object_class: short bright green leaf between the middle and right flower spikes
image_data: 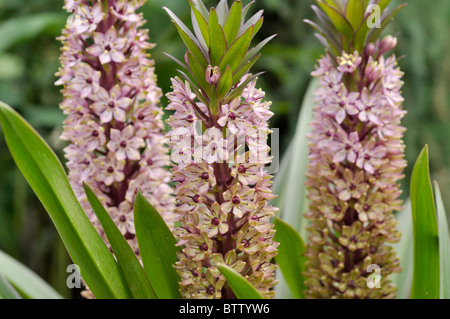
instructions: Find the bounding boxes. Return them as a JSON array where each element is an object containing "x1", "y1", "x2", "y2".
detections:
[{"x1": 274, "y1": 218, "x2": 306, "y2": 299}]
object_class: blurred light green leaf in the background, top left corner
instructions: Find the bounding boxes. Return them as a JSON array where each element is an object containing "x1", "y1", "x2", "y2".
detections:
[{"x1": 0, "y1": 13, "x2": 67, "y2": 52}]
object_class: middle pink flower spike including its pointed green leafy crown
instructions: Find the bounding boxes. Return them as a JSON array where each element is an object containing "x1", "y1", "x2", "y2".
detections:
[{"x1": 166, "y1": 0, "x2": 278, "y2": 299}]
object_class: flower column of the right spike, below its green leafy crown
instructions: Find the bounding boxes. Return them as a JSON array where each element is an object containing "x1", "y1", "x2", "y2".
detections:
[{"x1": 305, "y1": 1, "x2": 406, "y2": 298}]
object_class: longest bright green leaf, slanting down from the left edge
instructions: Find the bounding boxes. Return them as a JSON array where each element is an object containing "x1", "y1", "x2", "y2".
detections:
[{"x1": 0, "y1": 102, "x2": 129, "y2": 298}]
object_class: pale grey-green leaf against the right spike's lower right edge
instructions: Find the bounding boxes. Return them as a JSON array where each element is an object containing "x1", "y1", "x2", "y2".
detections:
[{"x1": 390, "y1": 199, "x2": 414, "y2": 299}]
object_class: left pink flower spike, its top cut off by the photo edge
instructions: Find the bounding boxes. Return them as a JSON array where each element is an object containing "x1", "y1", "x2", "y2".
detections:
[{"x1": 56, "y1": 0, "x2": 175, "y2": 264}]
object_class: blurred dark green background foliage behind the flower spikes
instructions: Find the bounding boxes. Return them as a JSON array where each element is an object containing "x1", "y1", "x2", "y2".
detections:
[{"x1": 0, "y1": 0, "x2": 450, "y2": 297}]
